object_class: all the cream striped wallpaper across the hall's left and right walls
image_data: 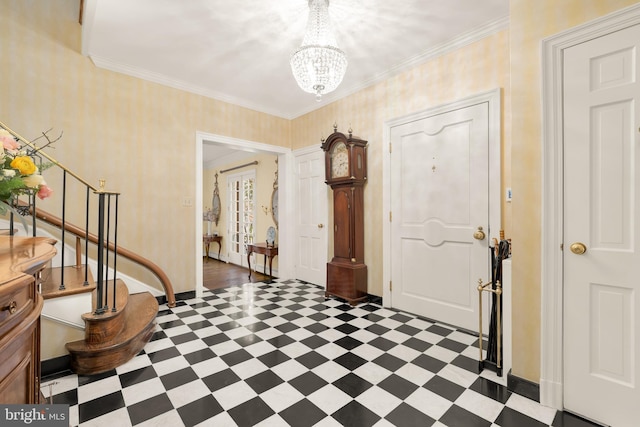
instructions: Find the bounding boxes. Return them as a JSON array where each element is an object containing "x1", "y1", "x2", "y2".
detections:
[{"x1": 0, "y1": 0, "x2": 636, "y2": 383}]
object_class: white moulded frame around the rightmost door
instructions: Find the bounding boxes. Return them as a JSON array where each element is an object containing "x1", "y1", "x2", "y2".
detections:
[{"x1": 540, "y1": 4, "x2": 640, "y2": 409}]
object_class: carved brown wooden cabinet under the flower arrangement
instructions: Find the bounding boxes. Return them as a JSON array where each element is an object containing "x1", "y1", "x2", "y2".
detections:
[{"x1": 0, "y1": 236, "x2": 55, "y2": 404}]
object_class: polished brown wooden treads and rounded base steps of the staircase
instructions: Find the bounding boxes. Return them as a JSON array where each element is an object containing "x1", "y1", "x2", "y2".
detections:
[{"x1": 41, "y1": 266, "x2": 158, "y2": 375}]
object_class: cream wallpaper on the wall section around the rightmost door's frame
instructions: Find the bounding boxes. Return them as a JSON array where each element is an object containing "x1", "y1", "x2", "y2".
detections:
[{"x1": 510, "y1": 0, "x2": 636, "y2": 383}]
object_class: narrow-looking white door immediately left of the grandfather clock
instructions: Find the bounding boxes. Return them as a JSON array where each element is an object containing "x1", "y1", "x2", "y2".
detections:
[{"x1": 295, "y1": 148, "x2": 328, "y2": 287}]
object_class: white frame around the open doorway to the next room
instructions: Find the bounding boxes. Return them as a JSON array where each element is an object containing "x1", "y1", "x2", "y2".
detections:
[{"x1": 193, "y1": 131, "x2": 295, "y2": 298}]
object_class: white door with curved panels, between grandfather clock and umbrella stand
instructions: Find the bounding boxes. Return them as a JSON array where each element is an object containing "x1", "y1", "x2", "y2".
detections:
[{"x1": 390, "y1": 102, "x2": 490, "y2": 331}]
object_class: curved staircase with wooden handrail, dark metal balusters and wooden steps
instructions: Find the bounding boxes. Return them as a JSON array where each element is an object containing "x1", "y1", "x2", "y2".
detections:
[{"x1": 0, "y1": 121, "x2": 176, "y2": 374}]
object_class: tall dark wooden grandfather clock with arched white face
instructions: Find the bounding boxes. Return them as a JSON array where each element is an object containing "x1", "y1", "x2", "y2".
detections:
[{"x1": 322, "y1": 125, "x2": 367, "y2": 305}]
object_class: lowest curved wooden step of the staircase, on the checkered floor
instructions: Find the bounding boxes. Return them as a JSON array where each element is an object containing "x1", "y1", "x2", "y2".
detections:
[{"x1": 66, "y1": 292, "x2": 158, "y2": 375}]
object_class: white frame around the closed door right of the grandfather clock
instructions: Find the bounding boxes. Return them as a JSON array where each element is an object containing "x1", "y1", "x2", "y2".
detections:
[{"x1": 382, "y1": 88, "x2": 502, "y2": 307}]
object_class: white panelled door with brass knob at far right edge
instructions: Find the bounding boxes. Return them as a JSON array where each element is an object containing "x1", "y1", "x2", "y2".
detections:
[{"x1": 563, "y1": 25, "x2": 640, "y2": 427}]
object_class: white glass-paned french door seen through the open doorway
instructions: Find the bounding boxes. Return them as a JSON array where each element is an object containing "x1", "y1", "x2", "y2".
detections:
[{"x1": 227, "y1": 170, "x2": 256, "y2": 267}]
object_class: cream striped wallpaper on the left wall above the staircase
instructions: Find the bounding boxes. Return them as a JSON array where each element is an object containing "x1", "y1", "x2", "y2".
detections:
[{"x1": 0, "y1": 0, "x2": 291, "y2": 292}]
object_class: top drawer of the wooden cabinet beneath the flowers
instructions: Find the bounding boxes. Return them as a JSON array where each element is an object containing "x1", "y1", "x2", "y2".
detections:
[{"x1": 0, "y1": 276, "x2": 35, "y2": 337}]
